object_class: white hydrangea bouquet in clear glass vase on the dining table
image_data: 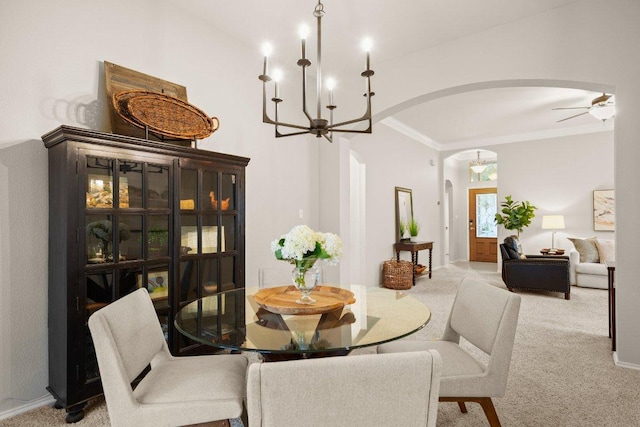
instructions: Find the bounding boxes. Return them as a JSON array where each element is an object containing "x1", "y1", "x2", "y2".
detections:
[{"x1": 271, "y1": 225, "x2": 342, "y2": 304}]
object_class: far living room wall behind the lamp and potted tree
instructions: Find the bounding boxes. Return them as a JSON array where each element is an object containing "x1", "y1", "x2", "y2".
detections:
[{"x1": 443, "y1": 131, "x2": 615, "y2": 261}]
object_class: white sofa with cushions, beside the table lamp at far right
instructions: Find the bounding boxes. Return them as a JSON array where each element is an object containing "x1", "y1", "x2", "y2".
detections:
[{"x1": 569, "y1": 238, "x2": 615, "y2": 289}]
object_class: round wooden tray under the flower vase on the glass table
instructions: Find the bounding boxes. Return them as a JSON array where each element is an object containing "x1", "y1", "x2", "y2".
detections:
[{"x1": 253, "y1": 286, "x2": 356, "y2": 314}]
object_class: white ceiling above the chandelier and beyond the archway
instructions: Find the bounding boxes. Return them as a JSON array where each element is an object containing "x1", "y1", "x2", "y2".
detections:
[{"x1": 174, "y1": 0, "x2": 613, "y2": 150}]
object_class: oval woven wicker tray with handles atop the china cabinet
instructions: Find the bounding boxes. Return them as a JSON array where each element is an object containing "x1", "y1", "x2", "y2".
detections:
[{"x1": 113, "y1": 90, "x2": 220, "y2": 139}]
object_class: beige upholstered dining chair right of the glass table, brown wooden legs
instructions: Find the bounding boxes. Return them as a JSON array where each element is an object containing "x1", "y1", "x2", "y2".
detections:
[{"x1": 378, "y1": 279, "x2": 520, "y2": 427}]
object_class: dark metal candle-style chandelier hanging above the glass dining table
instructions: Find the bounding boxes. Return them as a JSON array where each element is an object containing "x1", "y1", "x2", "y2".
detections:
[{"x1": 258, "y1": 0, "x2": 375, "y2": 142}]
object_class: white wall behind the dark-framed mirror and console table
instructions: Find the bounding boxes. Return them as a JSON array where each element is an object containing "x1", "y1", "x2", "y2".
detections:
[{"x1": 351, "y1": 124, "x2": 441, "y2": 286}]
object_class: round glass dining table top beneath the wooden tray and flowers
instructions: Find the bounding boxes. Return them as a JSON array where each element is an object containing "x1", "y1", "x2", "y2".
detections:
[{"x1": 175, "y1": 285, "x2": 431, "y2": 361}]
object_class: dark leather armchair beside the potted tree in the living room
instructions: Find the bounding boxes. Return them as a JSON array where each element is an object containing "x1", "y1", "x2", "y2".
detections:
[{"x1": 500, "y1": 237, "x2": 571, "y2": 300}]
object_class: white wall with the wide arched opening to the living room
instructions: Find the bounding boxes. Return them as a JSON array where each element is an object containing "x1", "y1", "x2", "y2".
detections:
[{"x1": 364, "y1": 0, "x2": 640, "y2": 369}]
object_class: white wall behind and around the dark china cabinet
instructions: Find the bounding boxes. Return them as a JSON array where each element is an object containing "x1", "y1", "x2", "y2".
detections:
[{"x1": 0, "y1": 0, "x2": 319, "y2": 414}]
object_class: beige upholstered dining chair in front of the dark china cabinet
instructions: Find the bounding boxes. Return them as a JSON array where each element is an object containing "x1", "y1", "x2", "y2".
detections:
[{"x1": 89, "y1": 289, "x2": 247, "y2": 427}]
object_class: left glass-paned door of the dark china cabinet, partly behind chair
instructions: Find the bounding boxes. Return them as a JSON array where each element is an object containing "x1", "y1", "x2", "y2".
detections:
[{"x1": 79, "y1": 153, "x2": 172, "y2": 381}]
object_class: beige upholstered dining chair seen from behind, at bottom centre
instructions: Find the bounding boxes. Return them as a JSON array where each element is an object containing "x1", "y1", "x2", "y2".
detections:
[{"x1": 247, "y1": 351, "x2": 442, "y2": 427}]
